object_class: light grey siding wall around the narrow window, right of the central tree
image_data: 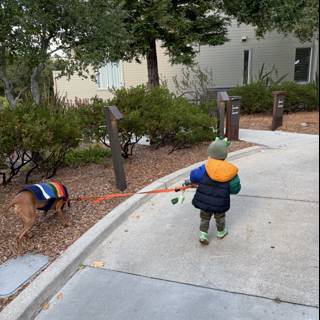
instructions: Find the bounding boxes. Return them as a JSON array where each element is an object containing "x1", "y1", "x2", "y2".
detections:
[{"x1": 197, "y1": 22, "x2": 313, "y2": 87}]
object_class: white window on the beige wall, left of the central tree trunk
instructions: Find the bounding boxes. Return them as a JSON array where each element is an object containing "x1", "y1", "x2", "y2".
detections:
[{"x1": 97, "y1": 63, "x2": 123, "y2": 90}]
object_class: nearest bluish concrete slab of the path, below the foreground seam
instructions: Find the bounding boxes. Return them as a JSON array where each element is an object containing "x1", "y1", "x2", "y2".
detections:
[{"x1": 37, "y1": 268, "x2": 317, "y2": 320}]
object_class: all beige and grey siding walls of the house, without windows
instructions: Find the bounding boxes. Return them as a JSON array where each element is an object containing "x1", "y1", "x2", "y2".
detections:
[{"x1": 54, "y1": 22, "x2": 318, "y2": 100}]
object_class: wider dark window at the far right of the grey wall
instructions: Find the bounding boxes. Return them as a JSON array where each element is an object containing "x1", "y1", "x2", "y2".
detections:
[{"x1": 294, "y1": 48, "x2": 311, "y2": 82}]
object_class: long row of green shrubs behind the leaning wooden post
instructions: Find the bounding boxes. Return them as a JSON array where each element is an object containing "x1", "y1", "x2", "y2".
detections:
[{"x1": 0, "y1": 86, "x2": 217, "y2": 184}]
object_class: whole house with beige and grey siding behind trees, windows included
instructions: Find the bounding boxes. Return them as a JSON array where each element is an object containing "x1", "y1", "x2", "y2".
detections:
[{"x1": 53, "y1": 21, "x2": 319, "y2": 100}]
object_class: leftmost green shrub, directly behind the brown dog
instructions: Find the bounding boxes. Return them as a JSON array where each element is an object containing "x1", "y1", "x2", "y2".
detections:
[{"x1": 0, "y1": 103, "x2": 81, "y2": 183}]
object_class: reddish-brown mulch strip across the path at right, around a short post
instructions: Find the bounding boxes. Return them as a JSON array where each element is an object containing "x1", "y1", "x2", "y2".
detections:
[{"x1": 240, "y1": 111, "x2": 319, "y2": 134}]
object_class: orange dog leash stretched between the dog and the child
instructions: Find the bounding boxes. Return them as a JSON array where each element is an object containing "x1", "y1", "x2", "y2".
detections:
[{"x1": 70, "y1": 185, "x2": 194, "y2": 204}]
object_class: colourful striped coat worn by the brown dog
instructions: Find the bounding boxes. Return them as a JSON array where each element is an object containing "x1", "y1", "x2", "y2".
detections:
[{"x1": 20, "y1": 181, "x2": 69, "y2": 211}]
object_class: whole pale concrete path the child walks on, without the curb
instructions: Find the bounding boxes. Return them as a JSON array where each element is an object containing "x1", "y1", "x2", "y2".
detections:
[{"x1": 33, "y1": 131, "x2": 319, "y2": 320}]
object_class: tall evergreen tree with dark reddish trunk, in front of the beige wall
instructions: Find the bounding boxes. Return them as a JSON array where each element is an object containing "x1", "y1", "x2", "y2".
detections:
[{"x1": 119, "y1": 0, "x2": 229, "y2": 86}]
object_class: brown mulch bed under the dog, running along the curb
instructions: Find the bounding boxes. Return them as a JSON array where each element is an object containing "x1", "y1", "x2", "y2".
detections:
[{"x1": 0, "y1": 141, "x2": 253, "y2": 311}]
